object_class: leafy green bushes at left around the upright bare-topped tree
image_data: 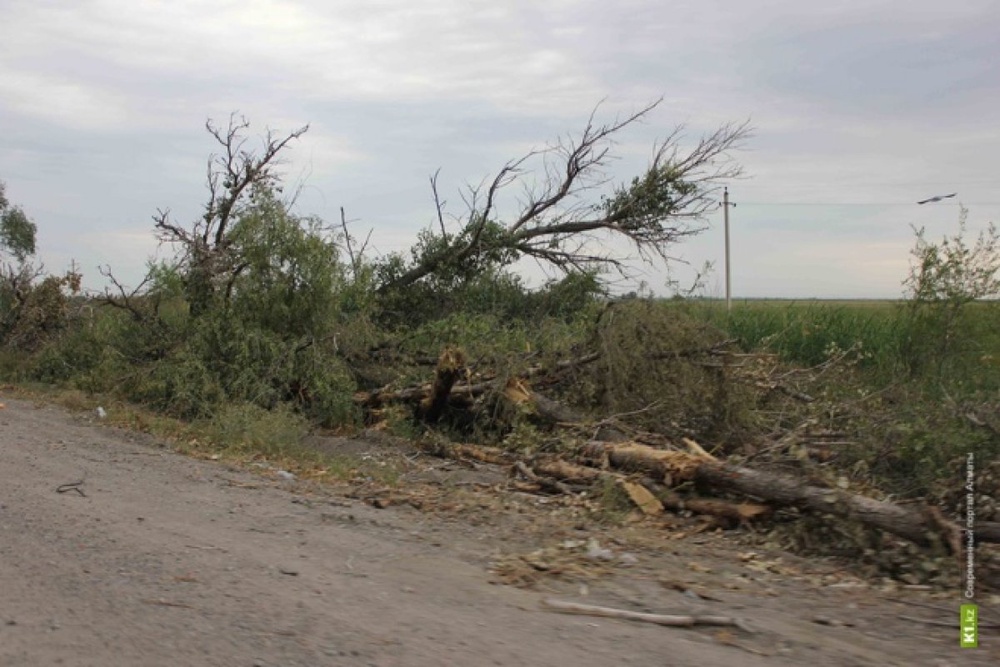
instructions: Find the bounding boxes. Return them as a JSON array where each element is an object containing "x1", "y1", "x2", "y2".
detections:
[{"x1": 8, "y1": 180, "x2": 369, "y2": 425}]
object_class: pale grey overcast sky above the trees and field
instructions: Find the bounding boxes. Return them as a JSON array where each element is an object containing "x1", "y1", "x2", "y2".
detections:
[{"x1": 0, "y1": 0, "x2": 1000, "y2": 298}]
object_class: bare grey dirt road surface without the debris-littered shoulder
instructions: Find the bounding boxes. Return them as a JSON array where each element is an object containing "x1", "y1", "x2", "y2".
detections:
[{"x1": 0, "y1": 400, "x2": 1000, "y2": 667}]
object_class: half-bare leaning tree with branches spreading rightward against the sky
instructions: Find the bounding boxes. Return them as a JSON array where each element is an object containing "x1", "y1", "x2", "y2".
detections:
[{"x1": 379, "y1": 102, "x2": 749, "y2": 293}]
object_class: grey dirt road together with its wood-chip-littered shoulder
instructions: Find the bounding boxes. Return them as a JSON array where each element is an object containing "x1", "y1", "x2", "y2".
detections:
[{"x1": 0, "y1": 400, "x2": 1000, "y2": 667}]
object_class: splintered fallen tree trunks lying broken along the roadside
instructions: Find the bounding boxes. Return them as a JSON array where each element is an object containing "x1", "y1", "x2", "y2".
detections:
[{"x1": 356, "y1": 341, "x2": 1000, "y2": 553}]
